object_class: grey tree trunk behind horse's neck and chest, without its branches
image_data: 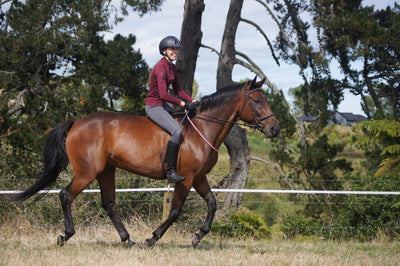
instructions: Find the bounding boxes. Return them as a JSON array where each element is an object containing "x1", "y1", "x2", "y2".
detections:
[{"x1": 217, "y1": 0, "x2": 250, "y2": 208}]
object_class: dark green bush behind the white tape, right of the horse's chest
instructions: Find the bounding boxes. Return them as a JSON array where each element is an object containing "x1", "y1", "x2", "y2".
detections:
[{"x1": 271, "y1": 134, "x2": 352, "y2": 217}]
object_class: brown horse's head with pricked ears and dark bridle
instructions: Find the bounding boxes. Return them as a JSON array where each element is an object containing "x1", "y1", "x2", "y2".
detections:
[{"x1": 240, "y1": 77, "x2": 280, "y2": 138}]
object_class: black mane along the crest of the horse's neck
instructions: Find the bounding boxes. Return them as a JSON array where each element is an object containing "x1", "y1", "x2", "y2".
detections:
[{"x1": 199, "y1": 82, "x2": 246, "y2": 112}]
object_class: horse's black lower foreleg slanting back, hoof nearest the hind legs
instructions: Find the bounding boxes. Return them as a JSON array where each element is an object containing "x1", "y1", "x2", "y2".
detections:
[{"x1": 144, "y1": 183, "x2": 190, "y2": 247}]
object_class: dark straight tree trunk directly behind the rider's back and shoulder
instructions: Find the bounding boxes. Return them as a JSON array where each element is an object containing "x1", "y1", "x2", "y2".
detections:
[{"x1": 176, "y1": 0, "x2": 205, "y2": 95}]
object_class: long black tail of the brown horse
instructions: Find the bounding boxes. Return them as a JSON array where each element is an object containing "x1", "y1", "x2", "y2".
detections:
[{"x1": 13, "y1": 120, "x2": 74, "y2": 201}]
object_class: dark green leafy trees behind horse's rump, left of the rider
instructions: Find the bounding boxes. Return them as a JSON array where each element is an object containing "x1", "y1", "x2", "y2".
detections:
[{"x1": 0, "y1": 0, "x2": 162, "y2": 176}]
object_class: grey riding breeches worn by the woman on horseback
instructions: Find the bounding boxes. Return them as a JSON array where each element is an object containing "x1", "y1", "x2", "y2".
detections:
[{"x1": 145, "y1": 104, "x2": 183, "y2": 145}]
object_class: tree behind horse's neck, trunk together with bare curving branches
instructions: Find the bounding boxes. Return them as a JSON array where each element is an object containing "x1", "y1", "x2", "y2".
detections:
[{"x1": 202, "y1": 0, "x2": 296, "y2": 207}]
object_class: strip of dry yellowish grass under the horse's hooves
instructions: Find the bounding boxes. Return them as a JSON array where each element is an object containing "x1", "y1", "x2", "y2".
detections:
[{"x1": 0, "y1": 217, "x2": 400, "y2": 265}]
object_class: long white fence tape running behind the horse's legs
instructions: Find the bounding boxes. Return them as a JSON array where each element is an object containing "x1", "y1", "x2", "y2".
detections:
[{"x1": 0, "y1": 187, "x2": 400, "y2": 195}]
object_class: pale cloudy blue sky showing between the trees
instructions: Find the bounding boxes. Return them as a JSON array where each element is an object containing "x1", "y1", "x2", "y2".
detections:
[{"x1": 105, "y1": 0, "x2": 396, "y2": 114}]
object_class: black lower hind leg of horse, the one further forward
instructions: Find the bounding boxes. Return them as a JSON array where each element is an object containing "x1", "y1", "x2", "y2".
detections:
[{"x1": 97, "y1": 166, "x2": 136, "y2": 247}]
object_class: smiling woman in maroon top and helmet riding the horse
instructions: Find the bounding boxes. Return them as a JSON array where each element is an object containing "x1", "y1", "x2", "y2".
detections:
[{"x1": 145, "y1": 36, "x2": 196, "y2": 183}]
